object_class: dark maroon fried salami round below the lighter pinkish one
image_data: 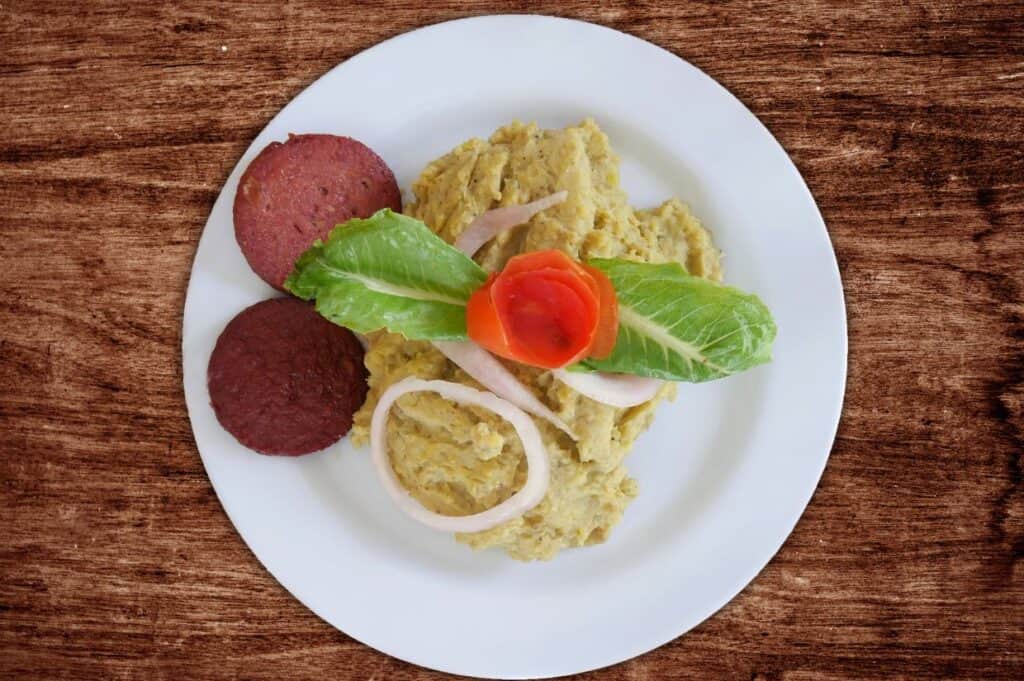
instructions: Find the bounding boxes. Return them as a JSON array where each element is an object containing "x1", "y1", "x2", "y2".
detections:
[{"x1": 207, "y1": 298, "x2": 367, "y2": 456}]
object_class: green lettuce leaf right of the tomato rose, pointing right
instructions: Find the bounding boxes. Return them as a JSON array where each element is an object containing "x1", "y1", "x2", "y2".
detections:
[{"x1": 583, "y1": 259, "x2": 775, "y2": 383}]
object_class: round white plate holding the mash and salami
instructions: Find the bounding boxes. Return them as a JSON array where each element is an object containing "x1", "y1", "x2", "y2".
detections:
[{"x1": 182, "y1": 15, "x2": 846, "y2": 678}]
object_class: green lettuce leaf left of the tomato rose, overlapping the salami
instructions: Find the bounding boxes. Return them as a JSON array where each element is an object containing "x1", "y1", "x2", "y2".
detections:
[{"x1": 285, "y1": 208, "x2": 486, "y2": 340}]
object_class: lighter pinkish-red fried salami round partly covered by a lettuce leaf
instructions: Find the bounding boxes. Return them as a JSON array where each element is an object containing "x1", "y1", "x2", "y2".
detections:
[{"x1": 233, "y1": 135, "x2": 401, "y2": 290}]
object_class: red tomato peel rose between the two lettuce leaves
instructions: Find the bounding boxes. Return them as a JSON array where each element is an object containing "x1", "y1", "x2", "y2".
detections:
[{"x1": 466, "y1": 250, "x2": 618, "y2": 369}]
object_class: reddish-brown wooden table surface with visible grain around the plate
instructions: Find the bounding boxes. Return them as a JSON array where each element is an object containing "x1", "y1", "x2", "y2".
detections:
[{"x1": 0, "y1": 0, "x2": 1024, "y2": 680}]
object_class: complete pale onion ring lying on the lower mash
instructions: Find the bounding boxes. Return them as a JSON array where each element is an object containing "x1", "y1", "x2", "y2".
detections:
[{"x1": 370, "y1": 378, "x2": 551, "y2": 533}]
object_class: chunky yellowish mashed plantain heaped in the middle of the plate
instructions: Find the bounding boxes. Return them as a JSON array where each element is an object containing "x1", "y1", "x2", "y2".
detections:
[{"x1": 353, "y1": 120, "x2": 721, "y2": 560}]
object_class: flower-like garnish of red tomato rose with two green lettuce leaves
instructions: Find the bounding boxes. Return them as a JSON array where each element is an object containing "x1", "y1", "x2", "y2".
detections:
[{"x1": 285, "y1": 210, "x2": 775, "y2": 382}]
